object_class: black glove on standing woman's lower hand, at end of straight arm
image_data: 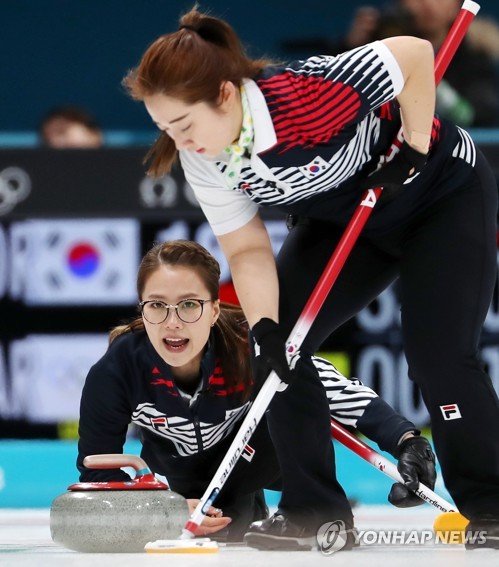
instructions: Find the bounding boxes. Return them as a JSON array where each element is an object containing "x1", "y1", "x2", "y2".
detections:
[{"x1": 252, "y1": 318, "x2": 292, "y2": 389}]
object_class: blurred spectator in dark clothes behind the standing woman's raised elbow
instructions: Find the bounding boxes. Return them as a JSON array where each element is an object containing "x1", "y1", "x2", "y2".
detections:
[{"x1": 283, "y1": 0, "x2": 499, "y2": 127}]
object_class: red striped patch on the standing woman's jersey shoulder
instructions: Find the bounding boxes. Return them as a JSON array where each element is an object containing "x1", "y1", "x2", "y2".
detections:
[{"x1": 257, "y1": 72, "x2": 360, "y2": 152}]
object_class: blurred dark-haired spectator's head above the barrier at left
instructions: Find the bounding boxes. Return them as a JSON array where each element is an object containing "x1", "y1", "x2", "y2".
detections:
[{"x1": 39, "y1": 106, "x2": 103, "y2": 149}]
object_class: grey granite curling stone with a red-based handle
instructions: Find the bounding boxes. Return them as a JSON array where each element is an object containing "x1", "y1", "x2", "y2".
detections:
[{"x1": 50, "y1": 454, "x2": 189, "y2": 553}]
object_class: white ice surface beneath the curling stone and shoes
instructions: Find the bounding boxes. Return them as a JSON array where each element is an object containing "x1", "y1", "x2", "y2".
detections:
[{"x1": 0, "y1": 505, "x2": 499, "y2": 567}]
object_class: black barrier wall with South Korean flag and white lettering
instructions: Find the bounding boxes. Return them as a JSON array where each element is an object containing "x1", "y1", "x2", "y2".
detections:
[{"x1": 0, "y1": 145, "x2": 499, "y2": 437}]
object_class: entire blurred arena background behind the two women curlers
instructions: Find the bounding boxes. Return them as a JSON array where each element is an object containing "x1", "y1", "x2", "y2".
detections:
[{"x1": 0, "y1": 0, "x2": 499, "y2": 507}]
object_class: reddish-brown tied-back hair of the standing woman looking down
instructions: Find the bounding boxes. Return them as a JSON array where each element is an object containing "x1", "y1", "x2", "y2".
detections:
[{"x1": 122, "y1": 7, "x2": 271, "y2": 177}]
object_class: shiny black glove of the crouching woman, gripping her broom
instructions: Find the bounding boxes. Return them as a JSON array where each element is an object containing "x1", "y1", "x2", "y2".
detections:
[{"x1": 388, "y1": 437, "x2": 437, "y2": 508}]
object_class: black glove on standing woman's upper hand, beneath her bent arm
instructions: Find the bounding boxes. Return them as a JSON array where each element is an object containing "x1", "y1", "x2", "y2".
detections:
[{"x1": 360, "y1": 140, "x2": 427, "y2": 197}]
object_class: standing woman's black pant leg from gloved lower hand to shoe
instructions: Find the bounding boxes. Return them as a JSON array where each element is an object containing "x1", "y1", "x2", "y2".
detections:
[{"x1": 267, "y1": 359, "x2": 353, "y2": 531}]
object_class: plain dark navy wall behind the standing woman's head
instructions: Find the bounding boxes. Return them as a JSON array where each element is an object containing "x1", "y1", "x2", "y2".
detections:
[{"x1": 0, "y1": 0, "x2": 394, "y2": 132}]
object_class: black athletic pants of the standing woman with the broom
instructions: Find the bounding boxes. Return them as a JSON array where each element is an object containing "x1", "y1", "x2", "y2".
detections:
[{"x1": 276, "y1": 153, "x2": 499, "y2": 519}]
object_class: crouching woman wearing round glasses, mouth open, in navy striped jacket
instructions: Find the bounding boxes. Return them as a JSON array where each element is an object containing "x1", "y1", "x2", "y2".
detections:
[{"x1": 77, "y1": 240, "x2": 435, "y2": 546}]
